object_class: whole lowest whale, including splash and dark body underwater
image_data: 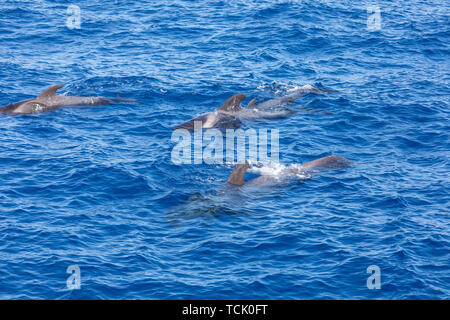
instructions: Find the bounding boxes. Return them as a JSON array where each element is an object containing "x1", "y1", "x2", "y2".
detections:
[{"x1": 166, "y1": 156, "x2": 350, "y2": 225}]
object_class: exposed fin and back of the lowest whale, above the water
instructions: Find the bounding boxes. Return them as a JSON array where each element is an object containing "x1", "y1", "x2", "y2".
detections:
[{"x1": 227, "y1": 156, "x2": 350, "y2": 186}]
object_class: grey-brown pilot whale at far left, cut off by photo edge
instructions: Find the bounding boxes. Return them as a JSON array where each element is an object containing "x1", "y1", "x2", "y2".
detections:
[{"x1": 0, "y1": 84, "x2": 136, "y2": 115}]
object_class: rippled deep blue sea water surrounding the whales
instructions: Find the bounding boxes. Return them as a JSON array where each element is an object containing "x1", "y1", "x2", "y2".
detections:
[{"x1": 0, "y1": 0, "x2": 450, "y2": 299}]
